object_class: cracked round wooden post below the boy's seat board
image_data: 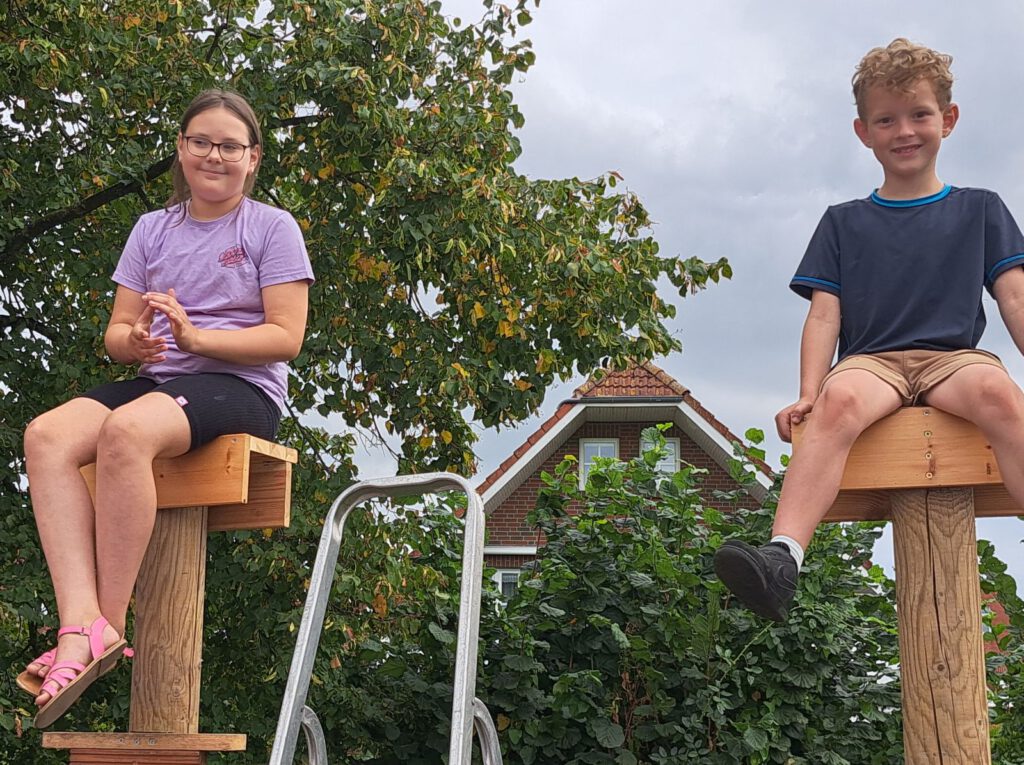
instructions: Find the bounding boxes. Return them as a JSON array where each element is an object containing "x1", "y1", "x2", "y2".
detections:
[{"x1": 893, "y1": 488, "x2": 991, "y2": 765}]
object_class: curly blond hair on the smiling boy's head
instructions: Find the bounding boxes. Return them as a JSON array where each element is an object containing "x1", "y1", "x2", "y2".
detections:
[{"x1": 853, "y1": 37, "x2": 953, "y2": 119}]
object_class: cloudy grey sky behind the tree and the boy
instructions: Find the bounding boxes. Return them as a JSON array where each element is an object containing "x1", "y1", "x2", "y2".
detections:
[{"x1": 359, "y1": 0, "x2": 1024, "y2": 583}]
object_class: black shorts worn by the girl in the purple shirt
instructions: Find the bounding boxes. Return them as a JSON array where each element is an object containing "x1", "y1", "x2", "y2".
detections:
[{"x1": 81, "y1": 374, "x2": 281, "y2": 450}]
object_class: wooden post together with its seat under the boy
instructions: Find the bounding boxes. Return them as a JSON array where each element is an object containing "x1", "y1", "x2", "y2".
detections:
[{"x1": 794, "y1": 407, "x2": 1024, "y2": 765}]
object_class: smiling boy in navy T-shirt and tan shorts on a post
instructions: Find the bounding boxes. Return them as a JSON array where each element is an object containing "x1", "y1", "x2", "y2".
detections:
[{"x1": 715, "y1": 38, "x2": 1024, "y2": 622}]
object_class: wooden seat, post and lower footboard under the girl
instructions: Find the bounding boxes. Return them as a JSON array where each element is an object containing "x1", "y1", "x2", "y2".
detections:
[{"x1": 43, "y1": 434, "x2": 298, "y2": 765}]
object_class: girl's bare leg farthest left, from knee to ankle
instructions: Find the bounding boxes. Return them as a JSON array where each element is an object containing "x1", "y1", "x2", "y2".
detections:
[{"x1": 25, "y1": 398, "x2": 111, "y2": 676}]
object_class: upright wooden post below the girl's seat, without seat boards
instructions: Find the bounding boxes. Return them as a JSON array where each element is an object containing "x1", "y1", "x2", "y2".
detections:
[{"x1": 134, "y1": 507, "x2": 207, "y2": 733}]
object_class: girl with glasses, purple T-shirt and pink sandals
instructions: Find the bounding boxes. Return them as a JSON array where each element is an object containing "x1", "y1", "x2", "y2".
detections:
[{"x1": 18, "y1": 90, "x2": 313, "y2": 728}]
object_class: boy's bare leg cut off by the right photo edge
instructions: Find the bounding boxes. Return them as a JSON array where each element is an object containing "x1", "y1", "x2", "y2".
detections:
[{"x1": 925, "y1": 364, "x2": 1024, "y2": 506}]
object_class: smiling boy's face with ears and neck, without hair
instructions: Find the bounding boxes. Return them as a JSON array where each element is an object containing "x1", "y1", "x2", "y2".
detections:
[{"x1": 853, "y1": 80, "x2": 959, "y2": 199}]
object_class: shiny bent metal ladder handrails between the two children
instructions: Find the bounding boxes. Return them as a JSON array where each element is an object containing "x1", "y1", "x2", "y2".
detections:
[{"x1": 269, "y1": 473, "x2": 502, "y2": 765}]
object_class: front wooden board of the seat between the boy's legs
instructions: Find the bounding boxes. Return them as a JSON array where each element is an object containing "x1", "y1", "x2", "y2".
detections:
[{"x1": 793, "y1": 407, "x2": 1002, "y2": 490}]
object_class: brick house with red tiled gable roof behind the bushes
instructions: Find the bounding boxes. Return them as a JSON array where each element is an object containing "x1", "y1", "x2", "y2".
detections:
[{"x1": 477, "y1": 363, "x2": 772, "y2": 592}]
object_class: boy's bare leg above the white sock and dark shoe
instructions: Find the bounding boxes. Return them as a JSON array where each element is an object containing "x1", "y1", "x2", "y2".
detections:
[{"x1": 772, "y1": 369, "x2": 902, "y2": 549}]
